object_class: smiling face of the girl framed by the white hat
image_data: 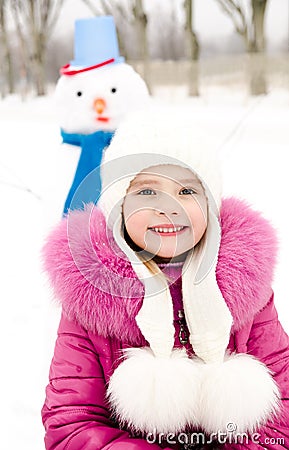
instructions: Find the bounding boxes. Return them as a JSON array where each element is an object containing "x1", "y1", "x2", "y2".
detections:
[{"x1": 123, "y1": 165, "x2": 207, "y2": 258}]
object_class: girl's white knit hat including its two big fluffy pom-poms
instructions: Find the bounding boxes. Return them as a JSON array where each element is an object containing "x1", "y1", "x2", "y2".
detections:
[{"x1": 99, "y1": 110, "x2": 276, "y2": 433}]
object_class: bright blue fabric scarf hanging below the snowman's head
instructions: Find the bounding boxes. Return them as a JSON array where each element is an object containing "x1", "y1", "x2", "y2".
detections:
[{"x1": 61, "y1": 130, "x2": 113, "y2": 215}]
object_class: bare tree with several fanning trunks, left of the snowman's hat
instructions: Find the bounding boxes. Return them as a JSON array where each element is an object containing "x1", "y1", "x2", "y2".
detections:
[{"x1": 11, "y1": 0, "x2": 65, "y2": 95}]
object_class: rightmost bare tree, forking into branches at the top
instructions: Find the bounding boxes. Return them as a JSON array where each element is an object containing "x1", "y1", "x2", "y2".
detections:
[{"x1": 217, "y1": 0, "x2": 268, "y2": 95}]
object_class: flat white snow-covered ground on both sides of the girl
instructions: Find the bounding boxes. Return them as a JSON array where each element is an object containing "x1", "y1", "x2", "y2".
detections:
[{"x1": 0, "y1": 89, "x2": 289, "y2": 450}]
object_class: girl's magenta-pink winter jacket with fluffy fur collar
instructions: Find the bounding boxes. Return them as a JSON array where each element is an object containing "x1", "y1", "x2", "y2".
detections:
[{"x1": 42, "y1": 199, "x2": 289, "y2": 450}]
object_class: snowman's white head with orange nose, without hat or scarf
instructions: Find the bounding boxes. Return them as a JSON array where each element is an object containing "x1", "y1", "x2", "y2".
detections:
[{"x1": 56, "y1": 63, "x2": 149, "y2": 134}]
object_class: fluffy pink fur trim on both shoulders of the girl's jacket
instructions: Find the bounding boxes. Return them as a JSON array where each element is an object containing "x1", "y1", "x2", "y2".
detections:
[{"x1": 43, "y1": 198, "x2": 277, "y2": 345}]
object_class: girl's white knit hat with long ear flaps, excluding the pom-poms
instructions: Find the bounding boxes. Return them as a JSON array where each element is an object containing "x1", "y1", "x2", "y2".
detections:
[{"x1": 99, "y1": 111, "x2": 232, "y2": 362}]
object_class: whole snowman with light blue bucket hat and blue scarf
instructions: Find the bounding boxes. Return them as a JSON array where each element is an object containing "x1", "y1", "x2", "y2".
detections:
[{"x1": 56, "y1": 16, "x2": 149, "y2": 214}]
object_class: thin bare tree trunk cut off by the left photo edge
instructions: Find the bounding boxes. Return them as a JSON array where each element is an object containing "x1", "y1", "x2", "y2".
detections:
[{"x1": 0, "y1": 0, "x2": 14, "y2": 96}]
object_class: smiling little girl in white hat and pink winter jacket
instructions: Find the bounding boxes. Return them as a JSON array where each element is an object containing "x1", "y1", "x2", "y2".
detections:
[{"x1": 42, "y1": 110, "x2": 289, "y2": 450}]
